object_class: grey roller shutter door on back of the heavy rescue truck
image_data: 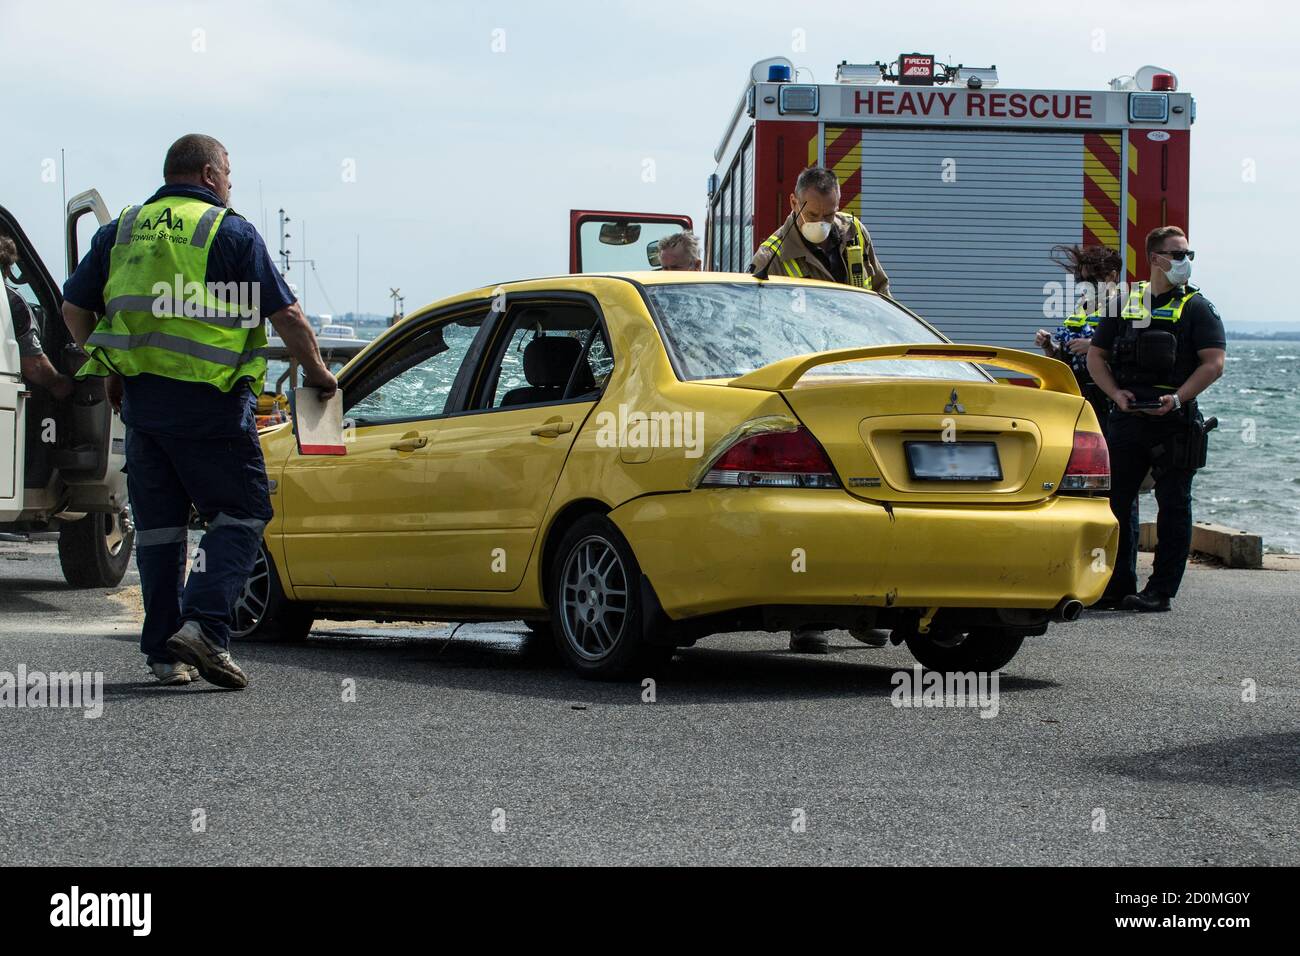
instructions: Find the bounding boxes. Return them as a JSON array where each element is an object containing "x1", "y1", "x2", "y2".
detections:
[{"x1": 826, "y1": 127, "x2": 1119, "y2": 350}]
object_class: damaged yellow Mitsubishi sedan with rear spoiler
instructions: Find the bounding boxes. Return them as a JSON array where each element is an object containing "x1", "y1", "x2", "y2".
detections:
[{"x1": 235, "y1": 272, "x2": 1118, "y2": 678}]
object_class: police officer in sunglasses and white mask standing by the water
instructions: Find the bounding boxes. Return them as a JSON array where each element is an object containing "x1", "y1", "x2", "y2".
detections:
[{"x1": 1088, "y1": 226, "x2": 1227, "y2": 611}]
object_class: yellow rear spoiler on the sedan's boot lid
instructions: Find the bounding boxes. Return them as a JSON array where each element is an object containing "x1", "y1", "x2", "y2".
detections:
[{"x1": 727, "y1": 342, "x2": 1083, "y2": 395}]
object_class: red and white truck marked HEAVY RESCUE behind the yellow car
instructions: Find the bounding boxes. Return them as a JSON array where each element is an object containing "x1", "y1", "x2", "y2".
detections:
[{"x1": 571, "y1": 53, "x2": 1196, "y2": 349}]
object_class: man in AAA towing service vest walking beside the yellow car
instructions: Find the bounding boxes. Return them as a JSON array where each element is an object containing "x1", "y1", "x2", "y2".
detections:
[{"x1": 64, "y1": 134, "x2": 337, "y2": 688}]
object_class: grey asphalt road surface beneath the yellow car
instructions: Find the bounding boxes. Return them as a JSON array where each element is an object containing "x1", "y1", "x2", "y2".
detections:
[{"x1": 0, "y1": 542, "x2": 1300, "y2": 865}]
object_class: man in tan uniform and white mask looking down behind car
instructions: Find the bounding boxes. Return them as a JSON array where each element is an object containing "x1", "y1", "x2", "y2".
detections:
[{"x1": 749, "y1": 166, "x2": 889, "y2": 295}]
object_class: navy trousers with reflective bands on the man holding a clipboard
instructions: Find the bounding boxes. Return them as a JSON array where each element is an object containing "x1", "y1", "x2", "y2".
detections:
[{"x1": 126, "y1": 428, "x2": 272, "y2": 663}]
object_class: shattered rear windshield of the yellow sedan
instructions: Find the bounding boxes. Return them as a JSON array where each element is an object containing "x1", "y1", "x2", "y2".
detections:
[{"x1": 645, "y1": 282, "x2": 988, "y2": 381}]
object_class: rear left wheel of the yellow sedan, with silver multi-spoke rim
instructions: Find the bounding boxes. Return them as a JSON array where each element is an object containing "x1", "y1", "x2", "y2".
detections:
[{"x1": 547, "y1": 515, "x2": 675, "y2": 680}]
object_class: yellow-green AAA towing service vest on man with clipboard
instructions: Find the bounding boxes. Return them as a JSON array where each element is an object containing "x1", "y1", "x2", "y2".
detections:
[{"x1": 77, "y1": 196, "x2": 267, "y2": 394}]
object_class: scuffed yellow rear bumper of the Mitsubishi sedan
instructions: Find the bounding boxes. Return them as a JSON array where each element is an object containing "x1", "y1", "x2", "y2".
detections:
[{"x1": 610, "y1": 489, "x2": 1119, "y2": 620}]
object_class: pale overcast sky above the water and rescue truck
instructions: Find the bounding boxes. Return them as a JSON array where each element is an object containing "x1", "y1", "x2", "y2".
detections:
[{"x1": 0, "y1": 0, "x2": 1300, "y2": 325}]
